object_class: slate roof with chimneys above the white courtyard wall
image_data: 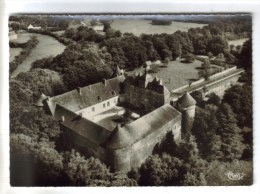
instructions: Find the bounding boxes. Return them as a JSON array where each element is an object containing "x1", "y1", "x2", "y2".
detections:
[{"x1": 49, "y1": 75, "x2": 125, "y2": 112}]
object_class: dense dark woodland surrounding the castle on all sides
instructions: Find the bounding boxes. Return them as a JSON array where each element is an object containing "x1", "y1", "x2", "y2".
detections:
[{"x1": 10, "y1": 16, "x2": 253, "y2": 186}]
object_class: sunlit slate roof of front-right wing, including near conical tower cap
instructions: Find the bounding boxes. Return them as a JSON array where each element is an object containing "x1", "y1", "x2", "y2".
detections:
[{"x1": 105, "y1": 104, "x2": 181, "y2": 149}]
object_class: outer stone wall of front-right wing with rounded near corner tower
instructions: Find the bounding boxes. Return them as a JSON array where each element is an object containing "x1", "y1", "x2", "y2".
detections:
[{"x1": 107, "y1": 116, "x2": 182, "y2": 171}]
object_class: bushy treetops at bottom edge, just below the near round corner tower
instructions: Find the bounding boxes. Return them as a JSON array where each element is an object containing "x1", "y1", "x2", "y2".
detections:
[{"x1": 64, "y1": 150, "x2": 137, "y2": 186}]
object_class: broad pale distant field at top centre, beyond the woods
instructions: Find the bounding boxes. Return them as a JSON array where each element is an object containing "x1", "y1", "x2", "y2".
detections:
[{"x1": 111, "y1": 19, "x2": 207, "y2": 36}]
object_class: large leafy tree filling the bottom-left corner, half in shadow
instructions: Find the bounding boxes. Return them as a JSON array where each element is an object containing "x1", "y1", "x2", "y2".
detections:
[{"x1": 10, "y1": 134, "x2": 63, "y2": 186}]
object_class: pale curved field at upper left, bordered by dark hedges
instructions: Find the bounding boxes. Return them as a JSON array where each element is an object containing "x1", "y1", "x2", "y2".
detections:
[{"x1": 10, "y1": 33, "x2": 65, "y2": 78}]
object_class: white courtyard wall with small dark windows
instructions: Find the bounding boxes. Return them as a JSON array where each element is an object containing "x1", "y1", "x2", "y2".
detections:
[{"x1": 76, "y1": 96, "x2": 118, "y2": 118}]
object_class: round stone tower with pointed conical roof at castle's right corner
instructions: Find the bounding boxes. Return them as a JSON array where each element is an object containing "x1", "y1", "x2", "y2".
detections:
[{"x1": 177, "y1": 92, "x2": 196, "y2": 137}]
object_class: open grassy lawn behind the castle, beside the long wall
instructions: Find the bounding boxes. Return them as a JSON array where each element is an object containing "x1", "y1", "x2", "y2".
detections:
[{"x1": 127, "y1": 59, "x2": 202, "y2": 91}]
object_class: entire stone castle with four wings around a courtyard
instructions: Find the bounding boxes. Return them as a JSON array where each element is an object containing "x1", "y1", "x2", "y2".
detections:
[{"x1": 36, "y1": 66, "x2": 196, "y2": 171}]
